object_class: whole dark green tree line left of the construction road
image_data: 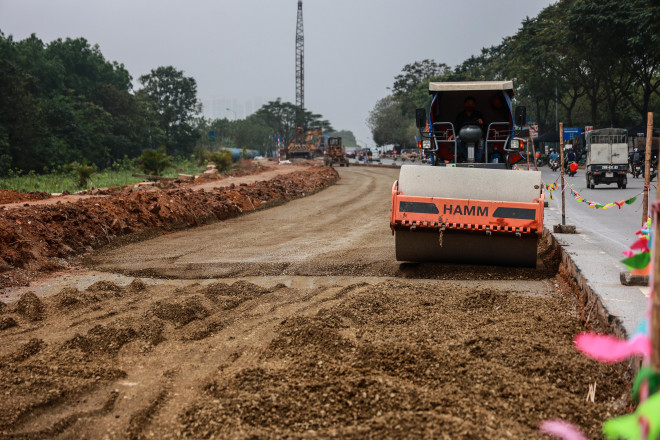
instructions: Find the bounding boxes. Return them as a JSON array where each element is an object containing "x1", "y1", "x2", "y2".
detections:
[{"x1": 0, "y1": 31, "x2": 354, "y2": 177}]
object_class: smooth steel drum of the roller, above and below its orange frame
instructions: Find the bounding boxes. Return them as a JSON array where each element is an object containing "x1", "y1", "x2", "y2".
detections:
[{"x1": 395, "y1": 165, "x2": 541, "y2": 267}]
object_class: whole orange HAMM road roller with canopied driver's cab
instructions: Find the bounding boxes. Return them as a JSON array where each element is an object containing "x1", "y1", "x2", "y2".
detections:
[{"x1": 390, "y1": 81, "x2": 544, "y2": 267}]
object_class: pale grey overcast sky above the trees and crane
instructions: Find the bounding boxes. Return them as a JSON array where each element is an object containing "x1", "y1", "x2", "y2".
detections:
[{"x1": 0, "y1": 0, "x2": 555, "y2": 147}]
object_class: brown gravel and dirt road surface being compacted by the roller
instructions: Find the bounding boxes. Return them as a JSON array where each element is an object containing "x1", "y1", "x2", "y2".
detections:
[{"x1": 0, "y1": 167, "x2": 628, "y2": 439}]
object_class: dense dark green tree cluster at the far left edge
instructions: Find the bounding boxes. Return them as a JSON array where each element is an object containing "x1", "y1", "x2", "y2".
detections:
[{"x1": 0, "y1": 32, "x2": 159, "y2": 176}]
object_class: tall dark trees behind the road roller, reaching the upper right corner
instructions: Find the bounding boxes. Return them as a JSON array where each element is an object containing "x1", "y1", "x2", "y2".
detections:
[{"x1": 367, "y1": 0, "x2": 660, "y2": 147}]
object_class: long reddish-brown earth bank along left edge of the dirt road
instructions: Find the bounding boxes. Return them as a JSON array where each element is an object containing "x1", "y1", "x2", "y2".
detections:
[{"x1": 0, "y1": 167, "x2": 339, "y2": 288}]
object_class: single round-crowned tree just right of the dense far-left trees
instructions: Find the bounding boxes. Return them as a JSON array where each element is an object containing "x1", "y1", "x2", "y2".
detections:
[{"x1": 138, "y1": 66, "x2": 201, "y2": 155}]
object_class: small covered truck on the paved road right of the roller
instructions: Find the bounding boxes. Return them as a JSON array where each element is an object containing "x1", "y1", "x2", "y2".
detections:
[{"x1": 585, "y1": 128, "x2": 628, "y2": 189}]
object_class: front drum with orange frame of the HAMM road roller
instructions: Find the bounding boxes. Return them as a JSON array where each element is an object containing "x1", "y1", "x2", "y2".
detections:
[{"x1": 392, "y1": 165, "x2": 543, "y2": 267}]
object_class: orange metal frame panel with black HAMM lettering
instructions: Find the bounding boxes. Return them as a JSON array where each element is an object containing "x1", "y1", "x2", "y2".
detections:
[{"x1": 390, "y1": 181, "x2": 545, "y2": 236}]
